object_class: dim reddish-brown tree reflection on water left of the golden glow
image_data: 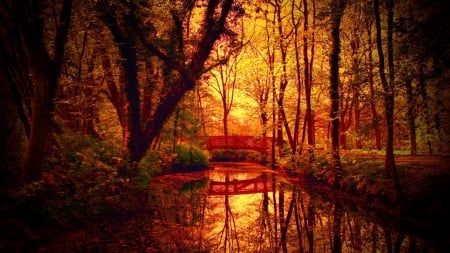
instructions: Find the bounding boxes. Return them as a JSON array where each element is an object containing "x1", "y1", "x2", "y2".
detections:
[{"x1": 150, "y1": 177, "x2": 209, "y2": 252}]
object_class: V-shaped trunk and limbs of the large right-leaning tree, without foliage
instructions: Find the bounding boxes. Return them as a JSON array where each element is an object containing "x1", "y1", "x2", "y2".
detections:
[{"x1": 96, "y1": 0, "x2": 233, "y2": 164}]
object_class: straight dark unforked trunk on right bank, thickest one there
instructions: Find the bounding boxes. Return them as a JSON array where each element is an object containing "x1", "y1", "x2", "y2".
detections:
[{"x1": 330, "y1": 0, "x2": 346, "y2": 184}]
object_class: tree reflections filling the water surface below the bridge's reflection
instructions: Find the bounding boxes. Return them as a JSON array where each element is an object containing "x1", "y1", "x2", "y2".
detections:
[{"x1": 151, "y1": 173, "x2": 439, "y2": 253}]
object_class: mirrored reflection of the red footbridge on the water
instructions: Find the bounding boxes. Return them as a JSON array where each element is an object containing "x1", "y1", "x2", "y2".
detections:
[{"x1": 209, "y1": 174, "x2": 273, "y2": 195}]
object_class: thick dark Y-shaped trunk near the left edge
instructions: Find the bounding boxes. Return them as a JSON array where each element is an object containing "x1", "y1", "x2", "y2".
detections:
[{"x1": 19, "y1": 0, "x2": 72, "y2": 184}]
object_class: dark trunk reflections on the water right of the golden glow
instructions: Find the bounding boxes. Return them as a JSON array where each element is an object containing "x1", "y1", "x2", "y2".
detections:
[{"x1": 268, "y1": 189, "x2": 439, "y2": 253}]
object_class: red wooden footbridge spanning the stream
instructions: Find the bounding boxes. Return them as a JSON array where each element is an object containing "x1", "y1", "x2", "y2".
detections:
[{"x1": 202, "y1": 135, "x2": 272, "y2": 151}]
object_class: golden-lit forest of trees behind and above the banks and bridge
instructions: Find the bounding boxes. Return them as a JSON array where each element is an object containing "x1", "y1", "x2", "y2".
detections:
[{"x1": 0, "y1": 0, "x2": 450, "y2": 190}]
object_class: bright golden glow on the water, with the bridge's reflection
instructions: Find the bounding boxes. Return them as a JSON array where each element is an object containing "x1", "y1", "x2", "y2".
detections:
[{"x1": 205, "y1": 170, "x2": 273, "y2": 252}]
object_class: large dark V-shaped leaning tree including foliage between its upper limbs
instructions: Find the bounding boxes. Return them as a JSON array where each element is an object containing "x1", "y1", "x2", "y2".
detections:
[{"x1": 97, "y1": 0, "x2": 242, "y2": 162}]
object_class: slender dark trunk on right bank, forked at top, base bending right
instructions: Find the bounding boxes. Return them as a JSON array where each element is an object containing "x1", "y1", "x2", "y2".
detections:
[{"x1": 374, "y1": 0, "x2": 402, "y2": 203}]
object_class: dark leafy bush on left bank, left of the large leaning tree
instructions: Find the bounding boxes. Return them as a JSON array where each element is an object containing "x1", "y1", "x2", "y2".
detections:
[{"x1": 24, "y1": 132, "x2": 134, "y2": 222}]
